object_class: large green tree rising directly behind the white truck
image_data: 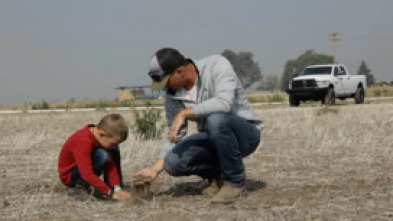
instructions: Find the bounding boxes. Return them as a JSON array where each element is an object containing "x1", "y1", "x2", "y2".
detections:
[{"x1": 281, "y1": 49, "x2": 333, "y2": 90}]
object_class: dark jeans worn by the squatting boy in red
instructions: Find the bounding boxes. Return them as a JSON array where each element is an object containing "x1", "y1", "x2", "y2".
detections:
[{"x1": 69, "y1": 147, "x2": 123, "y2": 187}]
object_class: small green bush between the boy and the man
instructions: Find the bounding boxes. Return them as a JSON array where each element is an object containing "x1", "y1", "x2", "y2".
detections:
[{"x1": 133, "y1": 107, "x2": 165, "y2": 140}]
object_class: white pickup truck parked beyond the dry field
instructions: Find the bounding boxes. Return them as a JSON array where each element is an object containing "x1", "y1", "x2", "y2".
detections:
[{"x1": 286, "y1": 64, "x2": 367, "y2": 107}]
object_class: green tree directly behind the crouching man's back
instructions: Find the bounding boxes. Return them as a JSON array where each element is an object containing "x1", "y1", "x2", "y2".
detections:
[{"x1": 221, "y1": 49, "x2": 262, "y2": 88}]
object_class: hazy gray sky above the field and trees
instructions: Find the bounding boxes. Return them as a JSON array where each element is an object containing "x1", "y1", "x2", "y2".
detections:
[{"x1": 0, "y1": 0, "x2": 393, "y2": 105}]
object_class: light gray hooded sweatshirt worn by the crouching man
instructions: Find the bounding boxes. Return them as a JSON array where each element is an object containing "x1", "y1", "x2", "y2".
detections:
[{"x1": 159, "y1": 55, "x2": 263, "y2": 158}]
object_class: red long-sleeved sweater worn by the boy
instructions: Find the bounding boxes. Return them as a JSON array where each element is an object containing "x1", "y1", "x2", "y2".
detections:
[{"x1": 58, "y1": 124, "x2": 120, "y2": 194}]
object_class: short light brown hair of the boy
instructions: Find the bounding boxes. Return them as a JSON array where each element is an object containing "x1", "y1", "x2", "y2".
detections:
[{"x1": 97, "y1": 114, "x2": 128, "y2": 141}]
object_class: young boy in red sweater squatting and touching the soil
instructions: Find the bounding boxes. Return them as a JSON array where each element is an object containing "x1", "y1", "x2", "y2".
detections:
[{"x1": 58, "y1": 114, "x2": 131, "y2": 200}]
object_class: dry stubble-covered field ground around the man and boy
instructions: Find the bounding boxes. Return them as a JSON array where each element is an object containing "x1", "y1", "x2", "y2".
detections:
[{"x1": 0, "y1": 103, "x2": 393, "y2": 221}]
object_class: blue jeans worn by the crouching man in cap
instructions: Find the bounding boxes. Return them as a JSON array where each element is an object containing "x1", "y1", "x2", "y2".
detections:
[{"x1": 164, "y1": 114, "x2": 261, "y2": 187}]
